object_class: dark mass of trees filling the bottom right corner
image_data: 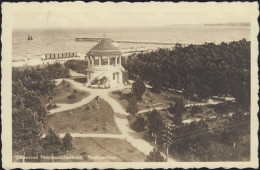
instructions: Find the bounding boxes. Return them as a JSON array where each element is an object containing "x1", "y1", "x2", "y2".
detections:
[{"x1": 169, "y1": 112, "x2": 250, "y2": 161}]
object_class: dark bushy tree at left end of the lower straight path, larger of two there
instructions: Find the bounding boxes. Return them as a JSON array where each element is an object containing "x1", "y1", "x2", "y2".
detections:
[{"x1": 43, "y1": 128, "x2": 62, "y2": 155}]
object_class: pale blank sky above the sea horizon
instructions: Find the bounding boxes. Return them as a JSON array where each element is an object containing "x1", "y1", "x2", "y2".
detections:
[{"x1": 12, "y1": 2, "x2": 255, "y2": 28}]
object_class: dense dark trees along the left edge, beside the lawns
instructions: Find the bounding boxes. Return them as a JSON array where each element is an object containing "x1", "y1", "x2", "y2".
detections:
[{"x1": 12, "y1": 64, "x2": 69, "y2": 156}]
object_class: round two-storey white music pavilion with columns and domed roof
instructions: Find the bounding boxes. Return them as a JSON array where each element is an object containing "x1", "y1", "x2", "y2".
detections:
[{"x1": 85, "y1": 38, "x2": 125, "y2": 88}]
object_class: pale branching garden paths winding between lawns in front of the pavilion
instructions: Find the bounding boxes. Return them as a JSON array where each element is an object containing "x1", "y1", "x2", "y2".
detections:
[{"x1": 49, "y1": 71, "x2": 174, "y2": 162}]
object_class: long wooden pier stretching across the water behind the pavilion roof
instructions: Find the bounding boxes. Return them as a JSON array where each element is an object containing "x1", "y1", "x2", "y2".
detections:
[{"x1": 75, "y1": 38, "x2": 176, "y2": 45}]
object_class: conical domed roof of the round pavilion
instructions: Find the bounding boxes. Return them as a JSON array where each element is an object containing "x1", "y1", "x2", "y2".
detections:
[{"x1": 87, "y1": 39, "x2": 122, "y2": 56}]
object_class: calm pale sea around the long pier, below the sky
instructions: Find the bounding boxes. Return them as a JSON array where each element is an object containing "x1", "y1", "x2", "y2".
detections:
[{"x1": 12, "y1": 26, "x2": 250, "y2": 60}]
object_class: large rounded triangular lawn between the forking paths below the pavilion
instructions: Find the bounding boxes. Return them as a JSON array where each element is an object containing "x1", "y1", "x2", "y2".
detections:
[{"x1": 48, "y1": 99, "x2": 120, "y2": 134}]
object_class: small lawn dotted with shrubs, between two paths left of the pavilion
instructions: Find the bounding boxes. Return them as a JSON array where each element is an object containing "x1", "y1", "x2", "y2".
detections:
[{"x1": 53, "y1": 81, "x2": 90, "y2": 104}]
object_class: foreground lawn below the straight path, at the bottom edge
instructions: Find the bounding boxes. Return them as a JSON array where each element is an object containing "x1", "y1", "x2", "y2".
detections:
[{"x1": 61, "y1": 138, "x2": 146, "y2": 162}]
